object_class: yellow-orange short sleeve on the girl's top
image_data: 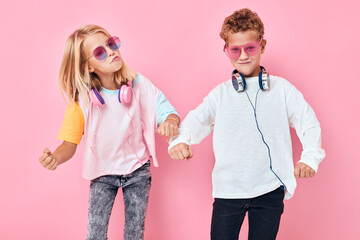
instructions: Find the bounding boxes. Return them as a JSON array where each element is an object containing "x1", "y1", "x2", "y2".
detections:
[{"x1": 58, "y1": 103, "x2": 85, "y2": 144}]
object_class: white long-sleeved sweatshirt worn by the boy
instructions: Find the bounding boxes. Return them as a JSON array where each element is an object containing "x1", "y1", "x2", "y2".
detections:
[{"x1": 169, "y1": 76, "x2": 325, "y2": 199}]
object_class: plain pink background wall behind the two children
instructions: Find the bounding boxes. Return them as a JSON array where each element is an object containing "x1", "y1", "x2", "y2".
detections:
[{"x1": 0, "y1": 0, "x2": 360, "y2": 240}]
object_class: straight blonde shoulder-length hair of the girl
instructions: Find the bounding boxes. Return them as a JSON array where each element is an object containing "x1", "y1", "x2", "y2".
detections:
[{"x1": 59, "y1": 25, "x2": 136, "y2": 103}]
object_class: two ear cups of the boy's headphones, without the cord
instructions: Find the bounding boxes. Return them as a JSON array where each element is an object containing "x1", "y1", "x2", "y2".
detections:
[{"x1": 231, "y1": 66, "x2": 270, "y2": 92}]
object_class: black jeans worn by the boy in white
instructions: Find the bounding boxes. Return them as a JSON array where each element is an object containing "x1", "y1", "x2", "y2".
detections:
[{"x1": 211, "y1": 188, "x2": 284, "y2": 240}]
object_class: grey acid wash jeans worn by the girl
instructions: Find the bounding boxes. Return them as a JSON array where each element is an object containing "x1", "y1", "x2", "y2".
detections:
[{"x1": 86, "y1": 161, "x2": 151, "y2": 240}]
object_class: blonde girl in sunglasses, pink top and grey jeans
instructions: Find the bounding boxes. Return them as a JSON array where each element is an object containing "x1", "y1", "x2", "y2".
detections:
[{"x1": 39, "y1": 25, "x2": 179, "y2": 240}]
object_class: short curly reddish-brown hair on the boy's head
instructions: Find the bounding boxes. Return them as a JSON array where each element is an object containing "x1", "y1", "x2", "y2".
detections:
[{"x1": 220, "y1": 8, "x2": 264, "y2": 43}]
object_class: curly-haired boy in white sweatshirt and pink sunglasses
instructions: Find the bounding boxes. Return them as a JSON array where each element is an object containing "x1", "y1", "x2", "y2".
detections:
[{"x1": 169, "y1": 9, "x2": 325, "y2": 240}]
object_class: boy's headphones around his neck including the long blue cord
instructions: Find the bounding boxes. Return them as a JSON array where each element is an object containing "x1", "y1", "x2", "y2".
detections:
[{"x1": 231, "y1": 66, "x2": 287, "y2": 191}]
